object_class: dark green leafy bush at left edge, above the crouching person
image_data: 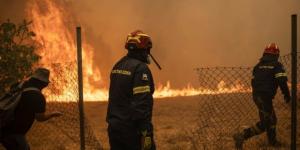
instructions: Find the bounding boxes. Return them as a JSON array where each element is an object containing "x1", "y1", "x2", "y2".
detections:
[{"x1": 0, "y1": 20, "x2": 41, "y2": 93}]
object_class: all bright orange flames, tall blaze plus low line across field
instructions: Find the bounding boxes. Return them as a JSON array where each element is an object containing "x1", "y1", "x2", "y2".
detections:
[{"x1": 27, "y1": 0, "x2": 250, "y2": 101}]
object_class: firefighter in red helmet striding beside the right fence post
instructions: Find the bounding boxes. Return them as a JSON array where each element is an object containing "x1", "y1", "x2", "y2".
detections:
[{"x1": 233, "y1": 43, "x2": 291, "y2": 149}]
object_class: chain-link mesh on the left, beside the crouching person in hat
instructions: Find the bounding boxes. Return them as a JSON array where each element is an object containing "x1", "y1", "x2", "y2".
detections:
[{"x1": 17, "y1": 62, "x2": 102, "y2": 150}]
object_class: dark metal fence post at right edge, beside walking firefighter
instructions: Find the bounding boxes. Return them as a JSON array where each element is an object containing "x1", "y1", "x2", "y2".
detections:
[{"x1": 291, "y1": 14, "x2": 297, "y2": 150}]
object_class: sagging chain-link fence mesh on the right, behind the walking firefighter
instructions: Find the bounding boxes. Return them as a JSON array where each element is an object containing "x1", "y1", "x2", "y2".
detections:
[{"x1": 190, "y1": 54, "x2": 300, "y2": 150}]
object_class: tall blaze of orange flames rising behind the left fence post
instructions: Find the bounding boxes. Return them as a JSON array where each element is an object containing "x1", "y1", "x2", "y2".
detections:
[{"x1": 27, "y1": 0, "x2": 107, "y2": 101}]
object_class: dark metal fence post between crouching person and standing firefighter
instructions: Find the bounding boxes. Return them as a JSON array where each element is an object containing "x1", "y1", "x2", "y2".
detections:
[{"x1": 76, "y1": 27, "x2": 85, "y2": 150}]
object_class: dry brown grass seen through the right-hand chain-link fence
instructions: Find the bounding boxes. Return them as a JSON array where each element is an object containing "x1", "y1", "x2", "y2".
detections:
[{"x1": 186, "y1": 93, "x2": 300, "y2": 149}]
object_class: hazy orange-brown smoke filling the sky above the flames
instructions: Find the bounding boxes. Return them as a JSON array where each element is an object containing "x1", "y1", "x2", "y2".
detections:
[{"x1": 0, "y1": 0, "x2": 300, "y2": 87}]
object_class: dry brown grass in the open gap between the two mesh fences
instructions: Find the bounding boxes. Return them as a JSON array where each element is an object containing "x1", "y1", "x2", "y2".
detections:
[{"x1": 85, "y1": 96, "x2": 201, "y2": 150}]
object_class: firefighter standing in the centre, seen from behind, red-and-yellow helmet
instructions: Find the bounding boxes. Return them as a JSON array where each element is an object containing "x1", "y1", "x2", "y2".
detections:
[{"x1": 106, "y1": 30, "x2": 155, "y2": 150}]
